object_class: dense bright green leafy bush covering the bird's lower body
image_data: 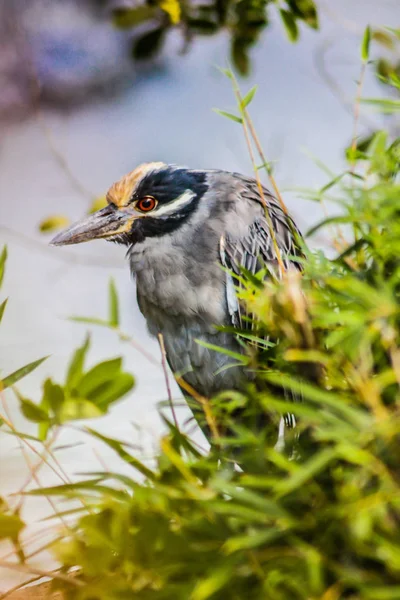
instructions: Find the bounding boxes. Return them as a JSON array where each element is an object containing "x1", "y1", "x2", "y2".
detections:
[{"x1": 10, "y1": 76, "x2": 400, "y2": 600}]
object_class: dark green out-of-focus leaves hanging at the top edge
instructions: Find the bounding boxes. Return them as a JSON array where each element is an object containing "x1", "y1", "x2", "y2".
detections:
[{"x1": 113, "y1": 0, "x2": 318, "y2": 74}]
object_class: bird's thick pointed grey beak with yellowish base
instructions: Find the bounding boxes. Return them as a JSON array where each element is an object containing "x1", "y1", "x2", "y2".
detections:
[{"x1": 50, "y1": 204, "x2": 135, "y2": 246}]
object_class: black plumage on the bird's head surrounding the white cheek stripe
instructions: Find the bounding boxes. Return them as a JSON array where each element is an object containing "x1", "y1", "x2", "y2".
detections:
[{"x1": 113, "y1": 167, "x2": 208, "y2": 244}]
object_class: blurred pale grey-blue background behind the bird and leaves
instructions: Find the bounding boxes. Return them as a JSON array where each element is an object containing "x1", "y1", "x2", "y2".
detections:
[{"x1": 0, "y1": 0, "x2": 400, "y2": 590}]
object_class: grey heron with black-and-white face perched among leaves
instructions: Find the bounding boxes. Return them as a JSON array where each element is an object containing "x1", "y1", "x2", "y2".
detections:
[{"x1": 51, "y1": 162, "x2": 302, "y2": 442}]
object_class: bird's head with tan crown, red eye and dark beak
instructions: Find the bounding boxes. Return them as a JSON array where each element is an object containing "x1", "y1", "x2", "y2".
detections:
[{"x1": 51, "y1": 163, "x2": 208, "y2": 246}]
